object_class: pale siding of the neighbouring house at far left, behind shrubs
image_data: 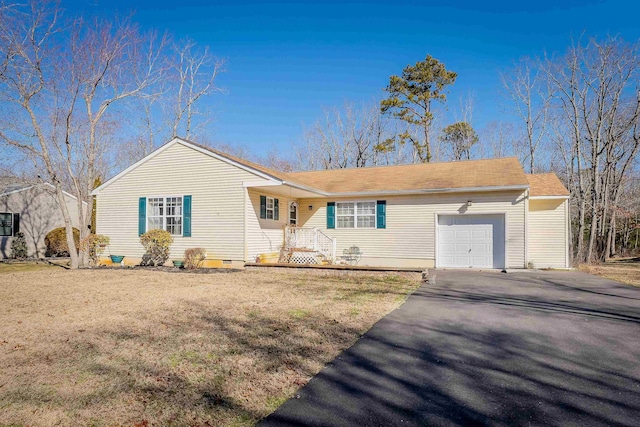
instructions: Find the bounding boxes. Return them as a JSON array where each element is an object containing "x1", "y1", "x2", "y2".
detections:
[{"x1": 0, "y1": 185, "x2": 78, "y2": 258}]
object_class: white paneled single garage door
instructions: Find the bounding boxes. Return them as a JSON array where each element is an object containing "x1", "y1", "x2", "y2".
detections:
[{"x1": 436, "y1": 215, "x2": 505, "y2": 268}]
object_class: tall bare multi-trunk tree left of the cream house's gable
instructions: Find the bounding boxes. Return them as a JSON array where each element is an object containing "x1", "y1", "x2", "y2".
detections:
[{"x1": 0, "y1": 0, "x2": 168, "y2": 268}]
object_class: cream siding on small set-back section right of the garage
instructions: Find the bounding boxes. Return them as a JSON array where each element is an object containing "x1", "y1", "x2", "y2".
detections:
[{"x1": 528, "y1": 199, "x2": 568, "y2": 268}]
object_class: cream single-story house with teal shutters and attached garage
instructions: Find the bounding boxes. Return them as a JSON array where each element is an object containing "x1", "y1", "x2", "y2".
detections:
[{"x1": 93, "y1": 138, "x2": 569, "y2": 268}]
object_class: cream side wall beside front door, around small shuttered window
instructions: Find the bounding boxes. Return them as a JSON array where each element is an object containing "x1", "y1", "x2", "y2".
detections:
[{"x1": 247, "y1": 190, "x2": 291, "y2": 261}]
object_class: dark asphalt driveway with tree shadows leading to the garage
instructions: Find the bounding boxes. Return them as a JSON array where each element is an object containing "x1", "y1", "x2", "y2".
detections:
[{"x1": 260, "y1": 271, "x2": 640, "y2": 427}]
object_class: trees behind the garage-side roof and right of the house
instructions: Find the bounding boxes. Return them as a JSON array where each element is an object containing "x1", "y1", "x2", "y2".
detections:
[{"x1": 298, "y1": 37, "x2": 640, "y2": 262}]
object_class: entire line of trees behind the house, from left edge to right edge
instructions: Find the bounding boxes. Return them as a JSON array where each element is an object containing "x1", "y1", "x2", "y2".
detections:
[{"x1": 0, "y1": 0, "x2": 640, "y2": 267}]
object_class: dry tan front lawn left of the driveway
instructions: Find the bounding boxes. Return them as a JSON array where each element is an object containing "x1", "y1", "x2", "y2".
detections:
[{"x1": 0, "y1": 269, "x2": 418, "y2": 426}]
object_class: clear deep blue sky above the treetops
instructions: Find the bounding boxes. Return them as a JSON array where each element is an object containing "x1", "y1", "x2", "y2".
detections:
[{"x1": 62, "y1": 0, "x2": 640, "y2": 156}]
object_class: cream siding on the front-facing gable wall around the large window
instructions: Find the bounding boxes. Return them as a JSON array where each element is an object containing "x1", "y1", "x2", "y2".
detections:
[{"x1": 97, "y1": 144, "x2": 266, "y2": 261}]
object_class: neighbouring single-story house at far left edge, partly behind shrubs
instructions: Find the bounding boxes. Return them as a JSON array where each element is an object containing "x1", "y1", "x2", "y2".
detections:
[{"x1": 0, "y1": 180, "x2": 85, "y2": 258}]
